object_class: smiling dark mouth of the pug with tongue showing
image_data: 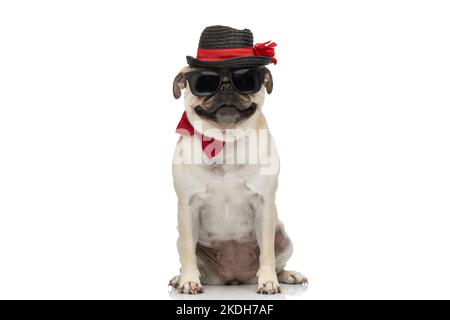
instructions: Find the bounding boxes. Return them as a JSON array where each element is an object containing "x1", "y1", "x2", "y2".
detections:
[{"x1": 194, "y1": 102, "x2": 258, "y2": 124}]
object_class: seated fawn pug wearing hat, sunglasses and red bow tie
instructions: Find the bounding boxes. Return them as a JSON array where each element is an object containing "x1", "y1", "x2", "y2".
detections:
[{"x1": 170, "y1": 26, "x2": 307, "y2": 294}]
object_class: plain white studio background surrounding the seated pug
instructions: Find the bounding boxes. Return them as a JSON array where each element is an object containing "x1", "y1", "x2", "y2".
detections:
[{"x1": 0, "y1": 0, "x2": 450, "y2": 299}]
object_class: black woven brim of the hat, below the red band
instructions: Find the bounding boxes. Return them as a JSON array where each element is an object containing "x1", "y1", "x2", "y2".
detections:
[{"x1": 186, "y1": 56, "x2": 272, "y2": 68}]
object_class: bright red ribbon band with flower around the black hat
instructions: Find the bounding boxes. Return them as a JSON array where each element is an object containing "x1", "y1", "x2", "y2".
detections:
[{"x1": 197, "y1": 41, "x2": 277, "y2": 64}]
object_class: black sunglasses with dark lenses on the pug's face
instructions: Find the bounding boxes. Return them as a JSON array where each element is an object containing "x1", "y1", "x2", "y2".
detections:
[{"x1": 184, "y1": 68, "x2": 266, "y2": 97}]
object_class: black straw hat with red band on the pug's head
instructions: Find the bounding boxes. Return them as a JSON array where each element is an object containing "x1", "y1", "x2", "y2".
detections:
[{"x1": 186, "y1": 26, "x2": 277, "y2": 68}]
